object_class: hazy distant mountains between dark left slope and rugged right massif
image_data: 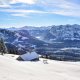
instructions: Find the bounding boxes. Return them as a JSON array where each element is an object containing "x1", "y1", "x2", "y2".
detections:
[{"x1": 20, "y1": 26, "x2": 51, "y2": 40}]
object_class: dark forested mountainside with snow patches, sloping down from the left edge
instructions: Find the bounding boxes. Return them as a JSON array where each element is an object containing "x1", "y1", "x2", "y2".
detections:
[{"x1": 0, "y1": 29, "x2": 48, "y2": 54}]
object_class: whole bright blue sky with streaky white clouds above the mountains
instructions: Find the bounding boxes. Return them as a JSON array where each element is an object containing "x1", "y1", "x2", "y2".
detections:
[{"x1": 0, "y1": 0, "x2": 80, "y2": 27}]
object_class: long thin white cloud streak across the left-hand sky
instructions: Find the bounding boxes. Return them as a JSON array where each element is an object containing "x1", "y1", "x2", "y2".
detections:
[{"x1": 0, "y1": 9, "x2": 48, "y2": 17}]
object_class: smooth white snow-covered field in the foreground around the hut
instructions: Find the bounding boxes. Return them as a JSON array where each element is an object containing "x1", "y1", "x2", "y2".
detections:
[{"x1": 0, "y1": 54, "x2": 80, "y2": 80}]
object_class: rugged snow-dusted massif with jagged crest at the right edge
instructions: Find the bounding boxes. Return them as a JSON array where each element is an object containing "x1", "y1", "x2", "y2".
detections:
[{"x1": 50, "y1": 24, "x2": 80, "y2": 40}]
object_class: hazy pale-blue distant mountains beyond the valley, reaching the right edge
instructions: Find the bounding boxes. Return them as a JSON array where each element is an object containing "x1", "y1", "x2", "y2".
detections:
[{"x1": 21, "y1": 24, "x2": 80, "y2": 42}]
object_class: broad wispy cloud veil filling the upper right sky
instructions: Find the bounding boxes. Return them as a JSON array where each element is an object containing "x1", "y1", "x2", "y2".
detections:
[{"x1": 37, "y1": 0, "x2": 80, "y2": 17}]
